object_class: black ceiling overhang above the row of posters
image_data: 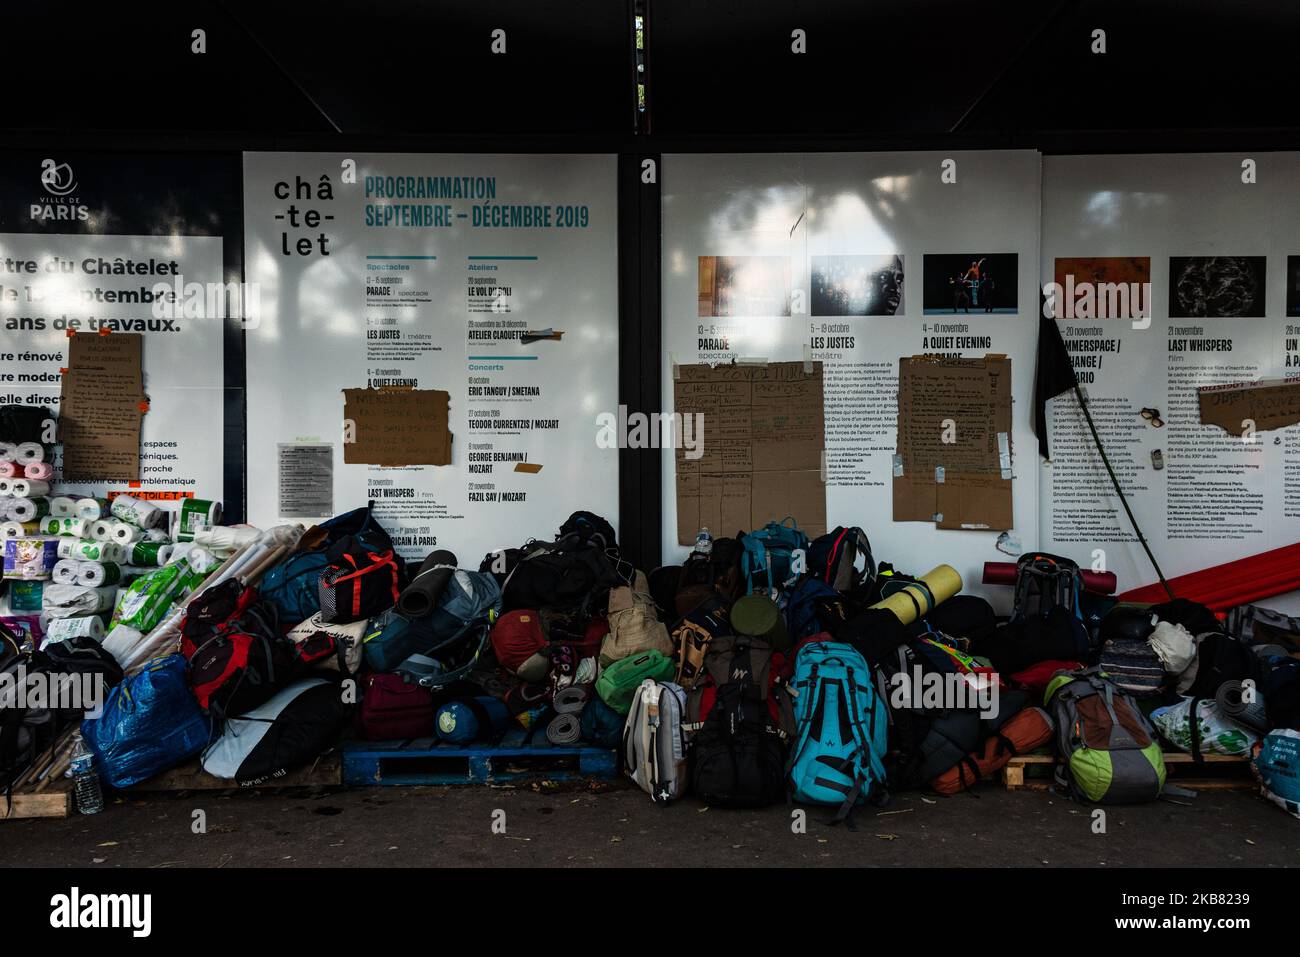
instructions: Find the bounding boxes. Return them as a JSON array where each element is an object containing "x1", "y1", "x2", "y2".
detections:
[{"x1": 10, "y1": 0, "x2": 1300, "y2": 148}]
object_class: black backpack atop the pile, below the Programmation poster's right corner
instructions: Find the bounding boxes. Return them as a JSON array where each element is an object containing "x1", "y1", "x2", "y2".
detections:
[{"x1": 501, "y1": 533, "x2": 625, "y2": 612}]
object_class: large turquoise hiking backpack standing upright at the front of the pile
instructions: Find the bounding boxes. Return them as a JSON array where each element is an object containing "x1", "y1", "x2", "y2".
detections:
[{"x1": 788, "y1": 641, "x2": 889, "y2": 823}]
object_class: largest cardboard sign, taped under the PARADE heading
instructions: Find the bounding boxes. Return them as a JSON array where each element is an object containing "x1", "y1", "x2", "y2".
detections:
[{"x1": 673, "y1": 363, "x2": 826, "y2": 545}]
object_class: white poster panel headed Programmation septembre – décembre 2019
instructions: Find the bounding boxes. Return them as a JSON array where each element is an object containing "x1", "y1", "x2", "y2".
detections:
[{"x1": 244, "y1": 152, "x2": 618, "y2": 564}]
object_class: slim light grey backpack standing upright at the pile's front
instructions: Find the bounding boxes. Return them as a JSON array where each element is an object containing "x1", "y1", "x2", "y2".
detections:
[{"x1": 623, "y1": 677, "x2": 686, "y2": 805}]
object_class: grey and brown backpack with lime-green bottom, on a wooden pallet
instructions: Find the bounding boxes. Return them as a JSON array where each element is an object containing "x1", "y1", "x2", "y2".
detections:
[{"x1": 1047, "y1": 668, "x2": 1165, "y2": 804}]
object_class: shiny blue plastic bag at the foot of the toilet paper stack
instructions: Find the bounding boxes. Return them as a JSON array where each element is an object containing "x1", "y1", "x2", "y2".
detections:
[{"x1": 82, "y1": 654, "x2": 211, "y2": 788}]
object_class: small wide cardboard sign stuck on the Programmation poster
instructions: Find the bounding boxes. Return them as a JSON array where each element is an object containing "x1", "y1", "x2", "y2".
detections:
[{"x1": 343, "y1": 389, "x2": 451, "y2": 467}]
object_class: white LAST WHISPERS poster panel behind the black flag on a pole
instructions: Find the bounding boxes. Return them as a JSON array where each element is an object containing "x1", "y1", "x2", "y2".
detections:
[{"x1": 1040, "y1": 153, "x2": 1300, "y2": 603}]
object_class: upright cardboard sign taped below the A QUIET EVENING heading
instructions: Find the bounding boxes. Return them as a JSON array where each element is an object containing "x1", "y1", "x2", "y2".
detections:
[{"x1": 893, "y1": 356, "x2": 1013, "y2": 531}]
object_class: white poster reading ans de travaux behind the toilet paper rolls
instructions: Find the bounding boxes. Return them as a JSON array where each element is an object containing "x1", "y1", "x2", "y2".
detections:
[{"x1": 0, "y1": 233, "x2": 225, "y2": 501}]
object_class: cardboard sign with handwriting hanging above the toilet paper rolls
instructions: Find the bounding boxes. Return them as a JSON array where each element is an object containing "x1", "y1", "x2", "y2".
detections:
[{"x1": 59, "y1": 333, "x2": 148, "y2": 482}]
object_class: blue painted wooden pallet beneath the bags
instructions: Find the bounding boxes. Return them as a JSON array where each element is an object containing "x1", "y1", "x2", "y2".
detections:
[{"x1": 343, "y1": 728, "x2": 619, "y2": 785}]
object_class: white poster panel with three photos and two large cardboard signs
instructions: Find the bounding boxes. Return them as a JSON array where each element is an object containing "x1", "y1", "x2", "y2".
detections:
[{"x1": 662, "y1": 151, "x2": 1040, "y2": 603}]
